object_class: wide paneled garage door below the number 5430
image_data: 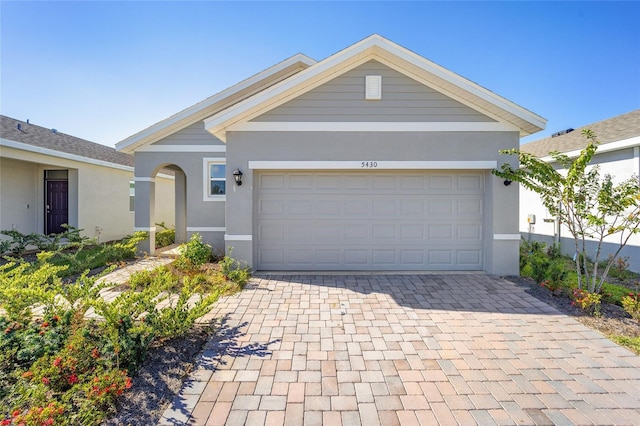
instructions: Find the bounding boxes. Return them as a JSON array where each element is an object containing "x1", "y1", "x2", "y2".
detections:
[{"x1": 256, "y1": 171, "x2": 484, "y2": 271}]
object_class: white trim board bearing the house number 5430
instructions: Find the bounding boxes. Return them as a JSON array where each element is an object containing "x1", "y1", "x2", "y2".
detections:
[{"x1": 249, "y1": 159, "x2": 498, "y2": 171}]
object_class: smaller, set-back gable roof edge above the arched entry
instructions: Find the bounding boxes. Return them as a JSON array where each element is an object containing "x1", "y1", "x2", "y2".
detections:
[{"x1": 116, "y1": 53, "x2": 316, "y2": 153}]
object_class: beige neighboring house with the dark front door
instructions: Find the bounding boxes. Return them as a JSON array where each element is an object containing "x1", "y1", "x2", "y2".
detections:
[{"x1": 0, "y1": 116, "x2": 174, "y2": 242}]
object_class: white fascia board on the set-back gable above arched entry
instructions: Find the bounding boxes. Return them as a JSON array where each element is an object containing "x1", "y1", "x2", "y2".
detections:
[{"x1": 116, "y1": 53, "x2": 316, "y2": 153}]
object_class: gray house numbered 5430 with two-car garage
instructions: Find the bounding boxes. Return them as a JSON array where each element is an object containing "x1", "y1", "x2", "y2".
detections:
[{"x1": 116, "y1": 35, "x2": 546, "y2": 274}]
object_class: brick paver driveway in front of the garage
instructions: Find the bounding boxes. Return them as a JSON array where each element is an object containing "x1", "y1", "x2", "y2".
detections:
[{"x1": 161, "y1": 274, "x2": 640, "y2": 426}]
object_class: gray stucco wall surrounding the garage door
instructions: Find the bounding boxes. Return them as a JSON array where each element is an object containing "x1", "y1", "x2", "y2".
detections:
[{"x1": 226, "y1": 132, "x2": 519, "y2": 275}]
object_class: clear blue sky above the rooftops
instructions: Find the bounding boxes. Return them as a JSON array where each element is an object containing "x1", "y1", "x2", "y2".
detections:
[{"x1": 0, "y1": 0, "x2": 640, "y2": 146}]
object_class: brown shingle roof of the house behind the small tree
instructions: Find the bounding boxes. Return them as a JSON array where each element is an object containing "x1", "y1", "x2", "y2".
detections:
[{"x1": 520, "y1": 109, "x2": 640, "y2": 157}]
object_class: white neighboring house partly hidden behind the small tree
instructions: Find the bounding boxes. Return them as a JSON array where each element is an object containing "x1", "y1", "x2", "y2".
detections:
[{"x1": 520, "y1": 110, "x2": 640, "y2": 271}]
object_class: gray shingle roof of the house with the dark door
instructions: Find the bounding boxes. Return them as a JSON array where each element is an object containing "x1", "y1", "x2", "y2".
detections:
[{"x1": 0, "y1": 115, "x2": 133, "y2": 170}]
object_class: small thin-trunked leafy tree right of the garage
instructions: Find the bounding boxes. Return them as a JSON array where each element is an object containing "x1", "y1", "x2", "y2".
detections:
[{"x1": 493, "y1": 129, "x2": 640, "y2": 293}]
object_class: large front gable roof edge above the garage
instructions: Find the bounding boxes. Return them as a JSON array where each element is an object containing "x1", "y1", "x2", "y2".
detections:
[{"x1": 205, "y1": 34, "x2": 546, "y2": 141}]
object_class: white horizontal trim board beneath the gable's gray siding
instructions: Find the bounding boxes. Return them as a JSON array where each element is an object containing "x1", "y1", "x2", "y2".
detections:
[{"x1": 227, "y1": 121, "x2": 520, "y2": 132}]
